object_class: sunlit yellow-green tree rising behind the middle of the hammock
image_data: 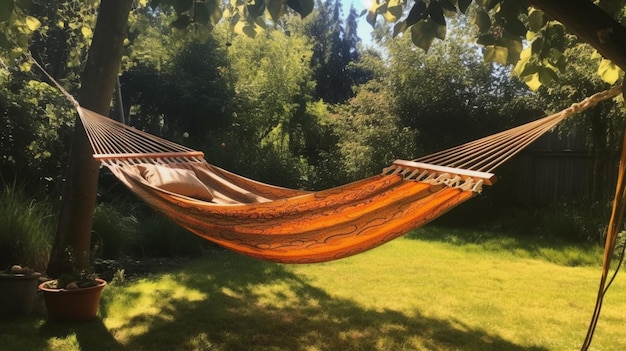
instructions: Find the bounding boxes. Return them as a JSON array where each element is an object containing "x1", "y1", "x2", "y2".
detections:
[{"x1": 215, "y1": 30, "x2": 314, "y2": 186}]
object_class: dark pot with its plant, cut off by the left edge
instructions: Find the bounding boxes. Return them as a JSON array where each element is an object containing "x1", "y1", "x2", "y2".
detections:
[{"x1": 0, "y1": 265, "x2": 41, "y2": 318}]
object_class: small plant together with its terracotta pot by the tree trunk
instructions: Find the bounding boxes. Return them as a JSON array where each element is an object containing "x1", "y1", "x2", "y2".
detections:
[{"x1": 39, "y1": 250, "x2": 107, "y2": 322}]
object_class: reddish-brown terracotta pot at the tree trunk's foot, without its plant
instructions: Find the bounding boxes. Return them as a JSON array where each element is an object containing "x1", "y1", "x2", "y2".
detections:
[{"x1": 39, "y1": 278, "x2": 107, "y2": 322}]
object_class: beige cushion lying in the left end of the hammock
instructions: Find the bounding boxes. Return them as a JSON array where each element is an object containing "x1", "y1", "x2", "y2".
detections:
[{"x1": 137, "y1": 164, "x2": 213, "y2": 201}]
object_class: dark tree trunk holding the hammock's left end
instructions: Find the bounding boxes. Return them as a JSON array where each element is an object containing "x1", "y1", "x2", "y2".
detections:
[{"x1": 47, "y1": 0, "x2": 132, "y2": 277}]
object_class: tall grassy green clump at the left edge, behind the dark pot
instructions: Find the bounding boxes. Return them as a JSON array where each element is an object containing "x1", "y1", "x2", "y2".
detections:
[{"x1": 0, "y1": 185, "x2": 55, "y2": 272}]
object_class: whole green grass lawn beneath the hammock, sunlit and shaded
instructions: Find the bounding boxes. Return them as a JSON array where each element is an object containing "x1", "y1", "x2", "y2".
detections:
[{"x1": 0, "y1": 232, "x2": 626, "y2": 351}]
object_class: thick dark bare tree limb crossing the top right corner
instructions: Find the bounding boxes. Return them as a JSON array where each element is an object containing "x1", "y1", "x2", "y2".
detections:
[{"x1": 528, "y1": 0, "x2": 626, "y2": 71}]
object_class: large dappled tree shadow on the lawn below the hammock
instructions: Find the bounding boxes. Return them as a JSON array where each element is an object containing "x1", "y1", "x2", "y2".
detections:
[{"x1": 90, "y1": 252, "x2": 544, "y2": 351}]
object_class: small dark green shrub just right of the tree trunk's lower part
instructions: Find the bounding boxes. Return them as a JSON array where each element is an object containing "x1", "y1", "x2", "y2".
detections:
[{"x1": 91, "y1": 203, "x2": 138, "y2": 258}]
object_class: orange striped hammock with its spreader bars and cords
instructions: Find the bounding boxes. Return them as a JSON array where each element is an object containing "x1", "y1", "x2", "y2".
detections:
[{"x1": 76, "y1": 87, "x2": 620, "y2": 263}]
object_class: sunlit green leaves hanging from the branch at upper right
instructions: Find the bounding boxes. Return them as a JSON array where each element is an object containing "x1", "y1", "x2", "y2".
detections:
[{"x1": 366, "y1": 0, "x2": 621, "y2": 89}]
